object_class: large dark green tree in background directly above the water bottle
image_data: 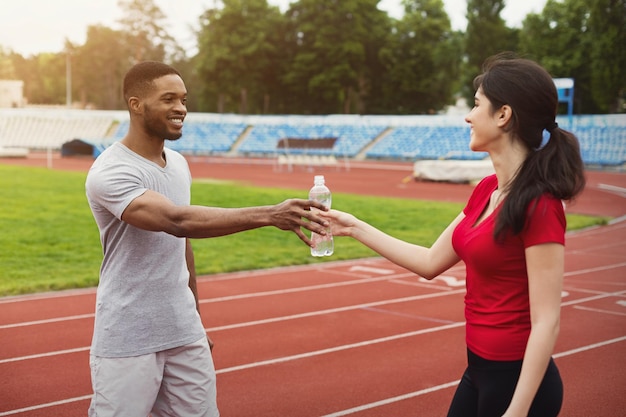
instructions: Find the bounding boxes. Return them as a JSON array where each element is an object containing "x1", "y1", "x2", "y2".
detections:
[{"x1": 284, "y1": 0, "x2": 388, "y2": 114}]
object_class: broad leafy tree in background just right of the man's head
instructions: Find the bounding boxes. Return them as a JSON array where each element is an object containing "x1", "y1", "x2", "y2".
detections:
[{"x1": 196, "y1": 0, "x2": 284, "y2": 113}]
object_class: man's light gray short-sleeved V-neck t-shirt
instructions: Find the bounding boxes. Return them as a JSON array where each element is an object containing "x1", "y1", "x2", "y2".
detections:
[{"x1": 85, "y1": 142, "x2": 206, "y2": 357}]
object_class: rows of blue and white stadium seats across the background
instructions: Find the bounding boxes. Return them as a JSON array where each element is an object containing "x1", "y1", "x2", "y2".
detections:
[{"x1": 0, "y1": 109, "x2": 626, "y2": 170}]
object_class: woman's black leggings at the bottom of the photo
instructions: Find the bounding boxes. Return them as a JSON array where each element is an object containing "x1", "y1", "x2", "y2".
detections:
[{"x1": 448, "y1": 350, "x2": 563, "y2": 417}]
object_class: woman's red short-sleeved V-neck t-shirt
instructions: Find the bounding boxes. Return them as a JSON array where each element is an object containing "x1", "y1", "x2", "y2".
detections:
[{"x1": 452, "y1": 175, "x2": 565, "y2": 361}]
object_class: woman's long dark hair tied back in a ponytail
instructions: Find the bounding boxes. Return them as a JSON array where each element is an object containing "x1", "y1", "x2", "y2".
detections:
[{"x1": 474, "y1": 53, "x2": 585, "y2": 239}]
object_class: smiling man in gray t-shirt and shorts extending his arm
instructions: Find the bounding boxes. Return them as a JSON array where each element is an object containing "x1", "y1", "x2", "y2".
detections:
[{"x1": 86, "y1": 61, "x2": 327, "y2": 417}]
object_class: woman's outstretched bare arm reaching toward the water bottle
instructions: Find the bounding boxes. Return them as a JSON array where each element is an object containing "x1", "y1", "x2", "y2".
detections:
[{"x1": 322, "y1": 210, "x2": 464, "y2": 279}]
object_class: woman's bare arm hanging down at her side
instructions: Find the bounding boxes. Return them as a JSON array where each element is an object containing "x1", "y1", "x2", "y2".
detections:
[{"x1": 504, "y1": 243, "x2": 565, "y2": 417}]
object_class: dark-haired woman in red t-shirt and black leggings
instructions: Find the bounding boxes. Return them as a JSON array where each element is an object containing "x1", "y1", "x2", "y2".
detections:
[{"x1": 325, "y1": 54, "x2": 585, "y2": 417}]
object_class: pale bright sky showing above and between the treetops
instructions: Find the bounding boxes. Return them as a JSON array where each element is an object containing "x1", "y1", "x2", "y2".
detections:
[{"x1": 0, "y1": 0, "x2": 546, "y2": 56}]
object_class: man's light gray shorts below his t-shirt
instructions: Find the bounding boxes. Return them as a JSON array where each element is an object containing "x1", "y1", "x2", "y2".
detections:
[{"x1": 89, "y1": 337, "x2": 219, "y2": 417}]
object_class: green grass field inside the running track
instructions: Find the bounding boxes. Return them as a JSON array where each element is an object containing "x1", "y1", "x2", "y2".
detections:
[{"x1": 0, "y1": 165, "x2": 607, "y2": 296}]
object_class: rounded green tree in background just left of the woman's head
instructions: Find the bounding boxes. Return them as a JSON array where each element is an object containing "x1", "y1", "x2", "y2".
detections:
[{"x1": 381, "y1": 0, "x2": 462, "y2": 114}]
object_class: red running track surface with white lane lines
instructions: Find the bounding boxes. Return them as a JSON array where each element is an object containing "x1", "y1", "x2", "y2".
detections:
[{"x1": 0, "y1": 154, "x2": 626, "y2": 417}]
